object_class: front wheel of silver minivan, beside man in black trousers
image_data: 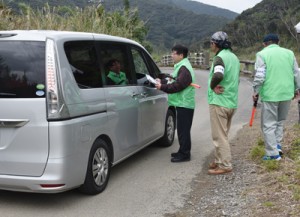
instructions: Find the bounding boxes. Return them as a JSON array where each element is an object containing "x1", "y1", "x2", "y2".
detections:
[{"x1": 158, "y1": 109, "x2": 176, "y2": 147}]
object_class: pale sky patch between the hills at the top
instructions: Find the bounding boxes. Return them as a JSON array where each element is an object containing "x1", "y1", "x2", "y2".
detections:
[{"x1": 194, "y1": 0, "x2": 262, "y2": 14}]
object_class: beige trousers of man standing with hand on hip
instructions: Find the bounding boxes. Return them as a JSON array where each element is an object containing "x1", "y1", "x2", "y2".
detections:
[{"x1": 209, "y1": 105, "x2": 236, "y2": 169}]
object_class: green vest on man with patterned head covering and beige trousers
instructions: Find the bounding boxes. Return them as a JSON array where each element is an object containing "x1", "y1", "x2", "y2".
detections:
[{"x1": 207, "y1": 49, "x2": 240, "y2": 109}]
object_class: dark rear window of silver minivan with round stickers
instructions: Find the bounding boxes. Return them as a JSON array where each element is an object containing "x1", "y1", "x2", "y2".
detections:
[{"x1": 0, "y1": 41, "x2": 46, "y2": 98}]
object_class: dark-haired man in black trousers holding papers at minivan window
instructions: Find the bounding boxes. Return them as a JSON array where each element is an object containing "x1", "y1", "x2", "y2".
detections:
[{"x1": 155, "y1": 45, "x2": 195, "y2": 162}]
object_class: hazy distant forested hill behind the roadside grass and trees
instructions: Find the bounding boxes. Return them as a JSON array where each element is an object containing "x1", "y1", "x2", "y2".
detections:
[{"x1": 2, "y1": 0, "x2": 238, "y2": 50}]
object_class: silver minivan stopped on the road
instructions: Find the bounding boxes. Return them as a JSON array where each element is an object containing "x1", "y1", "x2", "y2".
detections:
[{"x1": 0, "y1": 30, "x2": 176, "y2": 194}]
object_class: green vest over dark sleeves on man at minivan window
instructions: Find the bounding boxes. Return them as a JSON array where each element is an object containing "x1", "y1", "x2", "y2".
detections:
[{"x1": 168, "y1": 58, "x2": 195, "y2": 109}]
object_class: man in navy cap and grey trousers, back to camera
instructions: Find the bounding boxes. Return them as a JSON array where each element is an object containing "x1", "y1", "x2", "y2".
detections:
[{"x1": 253, "y1": 34, "x2": 300, "y2": 160}]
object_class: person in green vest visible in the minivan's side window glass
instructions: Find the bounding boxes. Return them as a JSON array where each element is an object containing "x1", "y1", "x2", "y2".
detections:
[{"x1": 106, "y1": 59, "x2": 128, "y2": 85}]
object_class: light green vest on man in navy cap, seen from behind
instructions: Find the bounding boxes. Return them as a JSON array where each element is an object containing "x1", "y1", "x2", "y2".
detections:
[{"x1": 257, "y1": 44, "x2": 295, "y2": 102}]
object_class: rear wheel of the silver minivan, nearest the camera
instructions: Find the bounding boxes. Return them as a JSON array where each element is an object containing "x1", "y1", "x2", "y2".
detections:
[{"x1": 79, "y1": 139, "x2": 111, "y2": 195}]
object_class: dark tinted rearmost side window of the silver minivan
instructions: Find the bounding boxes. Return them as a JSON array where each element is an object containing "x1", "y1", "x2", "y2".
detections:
[{"x1": 64, "y1": 41, "x2": 102, "y2": 89}]
